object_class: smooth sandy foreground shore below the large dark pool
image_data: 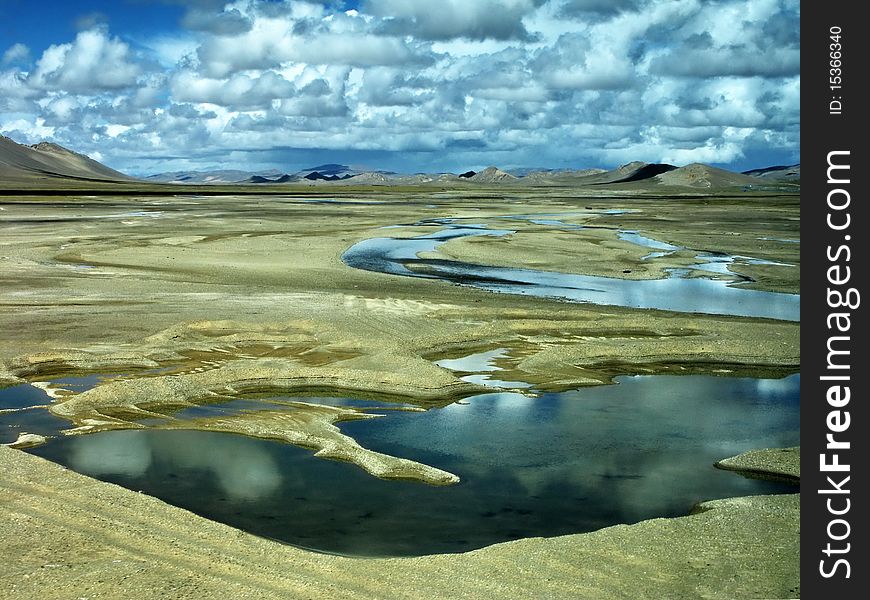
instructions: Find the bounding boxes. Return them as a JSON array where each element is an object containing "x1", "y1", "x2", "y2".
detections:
[{"x1": 0, "y1": 448, "x2": 800, "y2": 599}]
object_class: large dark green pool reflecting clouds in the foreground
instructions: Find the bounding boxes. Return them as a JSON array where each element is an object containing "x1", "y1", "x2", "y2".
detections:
[{"x1": 29, "y1": 376, "x2": 800, "y2": 556}]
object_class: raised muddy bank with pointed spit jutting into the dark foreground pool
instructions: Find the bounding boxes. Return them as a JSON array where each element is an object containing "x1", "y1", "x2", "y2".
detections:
[{"x1": 0, "y1": 310, "x2": 798, "y2": 484}]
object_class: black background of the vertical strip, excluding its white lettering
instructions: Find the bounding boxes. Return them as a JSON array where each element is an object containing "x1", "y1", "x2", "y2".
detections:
[{"x1": 801, "y1": 2, "x2": 870, "y2": 599}]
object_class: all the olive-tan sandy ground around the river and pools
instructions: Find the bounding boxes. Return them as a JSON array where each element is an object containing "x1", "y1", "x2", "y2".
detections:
[{"x1": 0, "y1": 190, "x2": 800, "y2": 598}]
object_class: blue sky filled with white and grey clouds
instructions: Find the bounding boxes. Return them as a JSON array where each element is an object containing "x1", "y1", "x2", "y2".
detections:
[{"x1": 0, "y1": 0, "x2": 800, "y2": 175}]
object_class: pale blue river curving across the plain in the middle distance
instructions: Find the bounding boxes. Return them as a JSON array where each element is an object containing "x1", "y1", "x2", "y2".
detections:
[{"x1": 342, "y1": 219, "x2": 800, "y2": 321}]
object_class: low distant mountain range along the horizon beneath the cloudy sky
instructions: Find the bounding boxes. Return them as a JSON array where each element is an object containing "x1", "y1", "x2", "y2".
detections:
[{"x1": 0, "y1": 136, "x2": 800, "y2": 189}]
